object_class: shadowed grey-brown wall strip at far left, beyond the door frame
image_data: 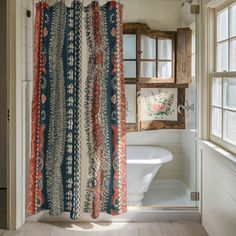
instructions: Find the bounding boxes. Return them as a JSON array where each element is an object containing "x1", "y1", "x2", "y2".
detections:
[{"x1": 0, "y1": 0, "x2": 7, "y2": 188}]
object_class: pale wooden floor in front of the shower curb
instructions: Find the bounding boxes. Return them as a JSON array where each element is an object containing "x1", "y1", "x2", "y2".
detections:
[{"x1": 0, "y1": 222, "x2": 207, "y2": 236}]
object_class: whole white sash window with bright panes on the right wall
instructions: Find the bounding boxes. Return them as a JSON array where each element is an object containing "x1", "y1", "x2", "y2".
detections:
[{"x1": 211, "y1": 2, "x2": 236, "y2": 152}]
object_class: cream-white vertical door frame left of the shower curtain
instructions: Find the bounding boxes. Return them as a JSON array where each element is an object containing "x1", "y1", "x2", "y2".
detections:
[{"x1": 7, "y1": 0, "x2": 25, "y2": 230}]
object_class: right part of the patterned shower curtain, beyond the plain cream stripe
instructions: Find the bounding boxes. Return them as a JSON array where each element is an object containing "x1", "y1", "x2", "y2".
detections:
[{"x1": 85, "y1": 1, "x2": 126, "y2": 218}]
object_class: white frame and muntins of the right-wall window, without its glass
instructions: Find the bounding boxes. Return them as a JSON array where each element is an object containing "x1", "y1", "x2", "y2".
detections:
[{"x1": 209, "y1": 0, "x2": 236, "y2": 154}]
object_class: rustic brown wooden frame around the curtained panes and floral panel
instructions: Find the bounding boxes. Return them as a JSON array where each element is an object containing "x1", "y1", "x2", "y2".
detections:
[{"x1": 123, "y1": 23, "x2": 188, "y2": 132}]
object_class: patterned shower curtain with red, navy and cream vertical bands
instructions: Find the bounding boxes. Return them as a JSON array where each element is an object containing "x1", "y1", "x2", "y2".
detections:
[{"x1": 27, "y1": 0, "x2": 126, "y2": 219}]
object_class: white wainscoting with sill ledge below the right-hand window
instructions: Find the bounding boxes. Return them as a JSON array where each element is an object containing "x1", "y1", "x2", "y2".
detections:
[{"x1": 201, "y1": 142, "x2": 236, "y2": 236}]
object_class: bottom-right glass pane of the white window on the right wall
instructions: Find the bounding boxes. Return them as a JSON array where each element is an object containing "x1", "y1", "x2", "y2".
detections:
[{"x1": 224, "y1": 111, "x2": 236, "y2": 144}]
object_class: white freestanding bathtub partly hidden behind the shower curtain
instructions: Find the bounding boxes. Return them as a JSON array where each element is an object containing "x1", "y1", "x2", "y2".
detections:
[{"x1": 126, "y1": 146, "x2": 173, "y2": 206}]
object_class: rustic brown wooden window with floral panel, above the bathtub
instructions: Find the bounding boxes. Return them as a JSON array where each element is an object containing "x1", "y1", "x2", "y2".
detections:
[{"x1": 123, "y1": 23, "x2": 191, "y2": 131}]
